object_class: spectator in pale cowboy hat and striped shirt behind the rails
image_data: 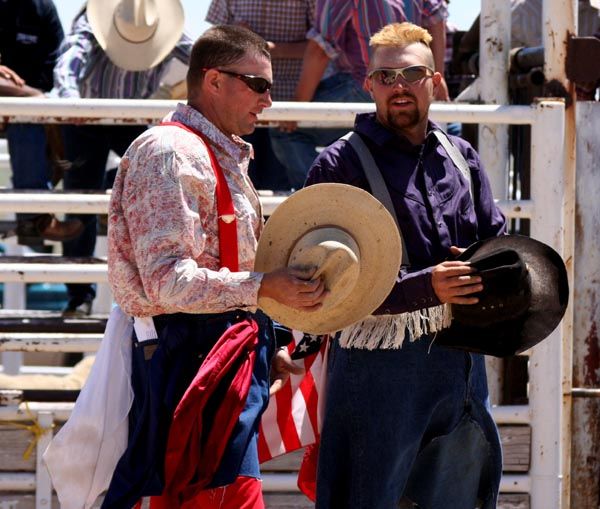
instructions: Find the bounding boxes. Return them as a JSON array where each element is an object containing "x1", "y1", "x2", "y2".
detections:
[{"x1": 53, "y1": 0, "x2": 192, "y2": 315}]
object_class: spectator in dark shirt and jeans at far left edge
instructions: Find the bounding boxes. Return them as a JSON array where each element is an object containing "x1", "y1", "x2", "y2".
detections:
[{"x1": 0, "y1": 0, "x2": 83, "y2": 245}]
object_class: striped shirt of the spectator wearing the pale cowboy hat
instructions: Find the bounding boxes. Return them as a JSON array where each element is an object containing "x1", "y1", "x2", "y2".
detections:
[{"x1": 51, "y1": 12, "x2": 193, "y2": 99}]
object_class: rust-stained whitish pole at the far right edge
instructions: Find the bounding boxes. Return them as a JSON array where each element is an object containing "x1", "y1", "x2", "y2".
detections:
[{"x1": 571, "y1": 101, "x2": 600, "y2": 508}]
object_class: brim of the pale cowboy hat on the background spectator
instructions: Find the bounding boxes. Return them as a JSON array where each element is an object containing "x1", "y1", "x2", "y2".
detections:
[{"x1": 86, "y1": 0, "x2": 184, "y2": 71}]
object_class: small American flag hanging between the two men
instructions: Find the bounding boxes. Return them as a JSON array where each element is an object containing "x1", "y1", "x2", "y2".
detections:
[{"x1": 258, "y1": 329, "x2": 327, "y2": 463}]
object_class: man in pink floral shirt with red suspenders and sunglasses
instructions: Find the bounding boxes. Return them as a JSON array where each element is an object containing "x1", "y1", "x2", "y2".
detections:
[{"x1": 102, "y1": 25, "x2": 326, "y2": 509}]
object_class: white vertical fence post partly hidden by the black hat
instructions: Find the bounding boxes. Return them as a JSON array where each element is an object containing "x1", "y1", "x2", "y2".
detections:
[{"x1": 529, "y1": 101, "x2": 570, "y2": 509}]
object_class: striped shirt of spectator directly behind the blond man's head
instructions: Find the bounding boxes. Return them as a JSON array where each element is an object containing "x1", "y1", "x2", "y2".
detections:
[{"x1": 308, "y1": 0, "x2": 448, "y2": 84}]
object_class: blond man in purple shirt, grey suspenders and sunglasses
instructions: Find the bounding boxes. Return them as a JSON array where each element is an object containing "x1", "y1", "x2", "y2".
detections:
[{"x1": 307, "y1": 23, "x2": 506, "y2": 509}]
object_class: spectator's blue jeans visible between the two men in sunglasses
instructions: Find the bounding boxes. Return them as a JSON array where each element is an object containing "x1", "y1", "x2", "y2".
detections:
[{"x1": 271, "y1": 73, "x2": 372, "y2": 189}]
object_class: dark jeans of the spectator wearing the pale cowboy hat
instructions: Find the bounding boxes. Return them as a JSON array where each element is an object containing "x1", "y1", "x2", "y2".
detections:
[{"x1": 63, "y1": 125, "x2": 146, "y2": 301}]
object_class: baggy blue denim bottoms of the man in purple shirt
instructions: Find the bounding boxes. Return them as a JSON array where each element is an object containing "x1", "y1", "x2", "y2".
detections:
[{"x1": 316, "y1": 337, "x2": 502, "y2": 509}]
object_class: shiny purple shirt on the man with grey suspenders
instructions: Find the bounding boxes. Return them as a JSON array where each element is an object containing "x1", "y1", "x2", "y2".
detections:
[{"x1": 306, "y1": 113, "x2": 506, "y2": 314}]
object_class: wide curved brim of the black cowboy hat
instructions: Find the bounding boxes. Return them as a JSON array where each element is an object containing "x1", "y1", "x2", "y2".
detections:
[{"x1": 435, "y1": 235, "x2": 569, "y2": 357}]
